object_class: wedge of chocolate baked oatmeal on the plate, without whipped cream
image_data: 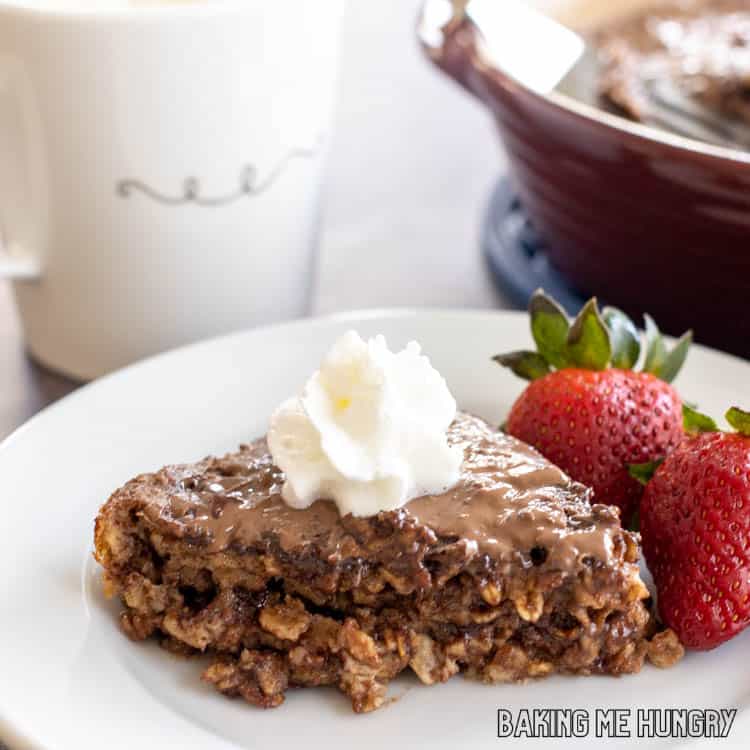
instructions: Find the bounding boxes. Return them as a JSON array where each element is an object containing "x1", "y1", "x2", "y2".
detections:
[{"x1": 95, "y1": 415, "x2": 682, "y2": 712}]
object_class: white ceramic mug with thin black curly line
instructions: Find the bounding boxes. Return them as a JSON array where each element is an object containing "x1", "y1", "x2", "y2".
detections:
[{"x1": 0, "y1": 0, "x2": 343, "y2": 379}]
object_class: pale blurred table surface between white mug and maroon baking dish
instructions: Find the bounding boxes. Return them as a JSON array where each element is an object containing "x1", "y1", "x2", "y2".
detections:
[{"x1": 313, "y1": 0, "x2": 507, "y2": 313}]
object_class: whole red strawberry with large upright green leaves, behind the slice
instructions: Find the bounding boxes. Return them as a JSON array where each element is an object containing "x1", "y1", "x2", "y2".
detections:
[{"x1": 495, "y1": 291, "x2": 691, "y2": 522}]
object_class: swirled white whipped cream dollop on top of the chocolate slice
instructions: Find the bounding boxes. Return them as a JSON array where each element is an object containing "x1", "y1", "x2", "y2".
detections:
[{"x1": 268, "y1": 331, "x2": 463, "y2": 516}]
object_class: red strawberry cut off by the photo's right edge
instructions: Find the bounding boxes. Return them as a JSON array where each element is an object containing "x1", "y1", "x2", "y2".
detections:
[{"x1": 641, "y1": 409, "x2": 750, "y2": 649}]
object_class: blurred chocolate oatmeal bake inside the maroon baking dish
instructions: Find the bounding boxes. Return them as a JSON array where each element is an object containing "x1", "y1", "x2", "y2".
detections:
[{"x1": 594, "y1": 0, "x2": 750, "y2": 148}]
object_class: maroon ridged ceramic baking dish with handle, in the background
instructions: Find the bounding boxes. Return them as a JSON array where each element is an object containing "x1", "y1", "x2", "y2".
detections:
[{"x1": 419, "y1": 0, "x2": 750, "y2": 356}]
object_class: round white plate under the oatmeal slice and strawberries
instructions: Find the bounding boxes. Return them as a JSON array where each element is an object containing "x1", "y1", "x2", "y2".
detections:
[{"x1": 0, "y1": 311, "x2": 750, "y2": 750}]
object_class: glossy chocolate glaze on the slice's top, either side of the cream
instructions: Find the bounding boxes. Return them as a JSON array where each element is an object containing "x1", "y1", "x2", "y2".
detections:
[{"x1": 135, "y1": 414, "x2": 622, "y2": 570}]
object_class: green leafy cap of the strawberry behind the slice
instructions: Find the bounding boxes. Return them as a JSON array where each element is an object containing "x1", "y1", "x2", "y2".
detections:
[{"x1": 493, "y1": 289, "x2": 692, "y2": 383}]
